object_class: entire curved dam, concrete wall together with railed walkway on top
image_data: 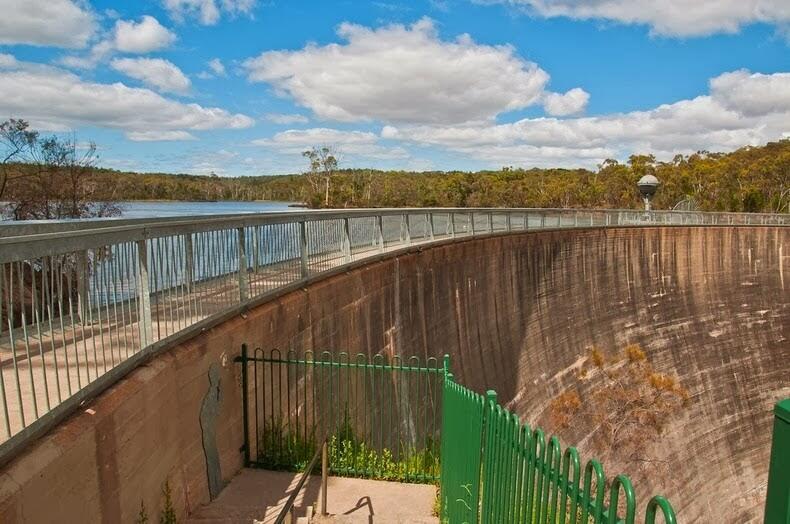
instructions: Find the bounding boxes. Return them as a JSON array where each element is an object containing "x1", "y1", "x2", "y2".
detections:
[{"x1": 0, "y1": 209, "x2": 790, "y2": 523}]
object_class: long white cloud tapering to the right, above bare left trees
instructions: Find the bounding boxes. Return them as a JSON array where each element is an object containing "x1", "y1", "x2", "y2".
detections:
[{"x1": 0, "y1": 63, "x2": 254, "y2": 141}]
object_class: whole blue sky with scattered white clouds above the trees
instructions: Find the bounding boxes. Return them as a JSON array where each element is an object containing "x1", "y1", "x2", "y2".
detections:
[{"x1": 0, "y1": 0, "x2": 790, "y2": 175}]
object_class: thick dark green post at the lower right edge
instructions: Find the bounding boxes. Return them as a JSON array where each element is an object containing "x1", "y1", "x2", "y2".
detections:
[{"x1": 765, "y1": 398, "x2": 790, "y2": 524}]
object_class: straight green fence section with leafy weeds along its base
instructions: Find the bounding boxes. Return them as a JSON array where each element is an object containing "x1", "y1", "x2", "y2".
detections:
[{"x1": 237, "y1": 346, "x2": 444, "y2": 482}]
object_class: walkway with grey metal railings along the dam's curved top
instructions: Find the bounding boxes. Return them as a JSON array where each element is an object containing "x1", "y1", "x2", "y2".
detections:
[{"x1": 0, "y1": 208, "x2": 790, "y2": 462}]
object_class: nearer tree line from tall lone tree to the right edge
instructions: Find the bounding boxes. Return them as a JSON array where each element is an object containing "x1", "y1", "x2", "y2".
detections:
[{"x1": 288, "y1": 139, "x2": 790, "y2": 213}]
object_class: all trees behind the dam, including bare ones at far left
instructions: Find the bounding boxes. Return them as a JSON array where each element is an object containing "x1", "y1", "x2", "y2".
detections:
[{"x1": 0, "y1": 120, "x2": 790, "y2": 219}]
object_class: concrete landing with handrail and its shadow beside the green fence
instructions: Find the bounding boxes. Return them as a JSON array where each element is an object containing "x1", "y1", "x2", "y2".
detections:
[{"x1": 187, "y1": 469, "x2": 439, "y2": 524}]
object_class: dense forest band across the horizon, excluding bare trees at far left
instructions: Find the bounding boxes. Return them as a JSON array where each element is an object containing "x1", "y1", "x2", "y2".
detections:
[{"x1": 5, "y1": 139, "x2": 790, "y2": 216}]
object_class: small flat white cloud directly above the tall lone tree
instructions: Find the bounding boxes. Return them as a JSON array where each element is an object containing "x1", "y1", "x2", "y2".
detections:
[{"x1": 252, "y1": 127, "x2": 409, "y2": 159}]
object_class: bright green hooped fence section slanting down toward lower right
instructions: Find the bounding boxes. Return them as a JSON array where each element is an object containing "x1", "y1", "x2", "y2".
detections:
[{"x1": 441, "y1": 366, "x2": 675, "y2": 524}]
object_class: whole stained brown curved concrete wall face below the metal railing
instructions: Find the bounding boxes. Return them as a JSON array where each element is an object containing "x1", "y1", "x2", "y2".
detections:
[{"x1": 0, "y1": 227, "x2": 790, "y2": 522}]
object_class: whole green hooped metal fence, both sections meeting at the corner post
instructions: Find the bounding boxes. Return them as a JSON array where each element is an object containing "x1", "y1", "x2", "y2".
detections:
[{"x1": 236, "y1": 346, "x2": 676, "y2": 524}]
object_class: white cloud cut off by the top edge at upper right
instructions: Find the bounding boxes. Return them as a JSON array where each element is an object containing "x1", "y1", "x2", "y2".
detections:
[{"x1": 486, "y1": 0, "x2": 790, "y2": 37}]
